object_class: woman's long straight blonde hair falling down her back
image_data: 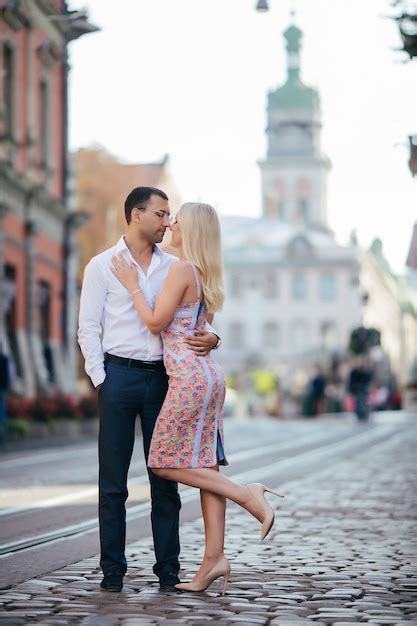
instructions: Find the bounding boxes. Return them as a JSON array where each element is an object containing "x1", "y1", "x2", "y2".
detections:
[{"x1": 176, "y1": 202, "x2": 224, "y2": 313}]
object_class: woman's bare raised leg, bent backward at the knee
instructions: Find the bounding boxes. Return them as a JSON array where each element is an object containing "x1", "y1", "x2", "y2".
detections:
[{"x1": 152, "y1": 467, "x2": 265, "y2": 522}]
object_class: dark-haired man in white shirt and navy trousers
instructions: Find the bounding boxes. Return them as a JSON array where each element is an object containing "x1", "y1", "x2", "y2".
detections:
[{"x1": 78, "y1": 187, "x2": 219, "y2": 592}]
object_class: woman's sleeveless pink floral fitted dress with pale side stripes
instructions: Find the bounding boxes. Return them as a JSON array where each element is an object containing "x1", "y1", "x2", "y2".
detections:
[{"x1": 148, "y1": 265, "x2": 227, "y2": 469}]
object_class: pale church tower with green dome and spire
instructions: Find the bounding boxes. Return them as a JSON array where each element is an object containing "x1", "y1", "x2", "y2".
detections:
[{"x1": 260, "y1": 19, "x2": 330, "y2": 230}]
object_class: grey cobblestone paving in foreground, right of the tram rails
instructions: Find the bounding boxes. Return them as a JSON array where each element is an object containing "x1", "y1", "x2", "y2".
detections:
[{"x1": 0, "y1": 425, "x2": 417, "y2": 626}]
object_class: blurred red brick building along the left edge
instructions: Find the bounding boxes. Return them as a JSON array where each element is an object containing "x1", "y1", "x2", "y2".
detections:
[{"x1": 0, "y1": 0, "x2": 97, "y2": 396}]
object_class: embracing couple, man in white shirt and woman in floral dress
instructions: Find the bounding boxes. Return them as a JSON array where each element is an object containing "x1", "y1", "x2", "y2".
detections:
[{"x1": 78, "y1": 187, "x2": 282, "y2": 592}]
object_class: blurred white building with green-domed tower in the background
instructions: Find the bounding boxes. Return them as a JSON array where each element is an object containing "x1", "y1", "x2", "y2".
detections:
[{"x1": 215, "y1": 25, "x2": 361, "y2": 372}]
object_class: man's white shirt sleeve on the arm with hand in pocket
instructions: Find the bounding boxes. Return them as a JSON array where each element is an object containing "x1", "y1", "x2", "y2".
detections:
[{"x1": 78, "y1": 259, "x2": 107, "y2": 387}]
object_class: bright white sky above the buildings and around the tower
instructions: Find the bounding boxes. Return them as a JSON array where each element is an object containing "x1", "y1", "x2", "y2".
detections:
[{"x1": 69, "y1": 0, "x2": 417, "y2": 273}]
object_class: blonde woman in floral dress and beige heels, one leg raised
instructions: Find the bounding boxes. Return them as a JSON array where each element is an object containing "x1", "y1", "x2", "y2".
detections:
[{"x1": 113, "y1": 203, "x2": 278, "y2": 594}]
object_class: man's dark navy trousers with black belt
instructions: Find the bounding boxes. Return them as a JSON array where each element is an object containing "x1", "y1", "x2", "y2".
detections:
[{"x1": 98, "y1": 363, "x2": 181, "y2": 578}]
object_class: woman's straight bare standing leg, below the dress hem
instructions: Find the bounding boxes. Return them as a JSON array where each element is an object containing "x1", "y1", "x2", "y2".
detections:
[{"x1": 193, "y1": 466, "x2": 226, "y2": 582}]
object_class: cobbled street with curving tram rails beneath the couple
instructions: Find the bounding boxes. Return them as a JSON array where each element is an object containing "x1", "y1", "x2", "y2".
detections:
[{"x1": 0, "y1": 413, "x2": 417, "y2": 625}]
